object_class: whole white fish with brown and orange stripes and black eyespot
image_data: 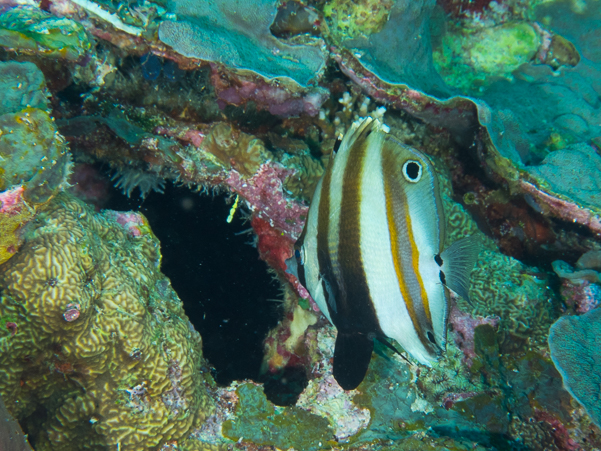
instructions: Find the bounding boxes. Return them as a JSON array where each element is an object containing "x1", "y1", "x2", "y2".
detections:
[{"x1": 287, "y1": 117, "x2": 480, "y2": 390}]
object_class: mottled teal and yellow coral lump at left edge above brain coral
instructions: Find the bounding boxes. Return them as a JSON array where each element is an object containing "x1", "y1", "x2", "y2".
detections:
[{"x1": 0, "y1": 62, "x2": 71, "y2": 263}]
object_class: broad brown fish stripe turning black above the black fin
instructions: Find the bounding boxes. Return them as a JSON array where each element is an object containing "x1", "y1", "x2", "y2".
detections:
[{"x1": 337, "y1": 126, "x2": 382, "y2": 334}]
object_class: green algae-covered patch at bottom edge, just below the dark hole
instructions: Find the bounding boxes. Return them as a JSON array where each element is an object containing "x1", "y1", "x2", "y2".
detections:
[{"x1": 223, "y1": 383, "x2": 334, "y2": 451}]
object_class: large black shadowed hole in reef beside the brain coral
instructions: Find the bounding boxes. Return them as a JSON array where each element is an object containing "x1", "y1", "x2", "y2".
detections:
[{"x1": 104, "y1": 183, "x2": 281, "y2": 385}]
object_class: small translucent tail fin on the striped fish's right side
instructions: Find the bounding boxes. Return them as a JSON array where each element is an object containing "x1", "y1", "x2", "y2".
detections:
[{"x1": 436, "y1": 235, "x2": 482, "y2": 302}]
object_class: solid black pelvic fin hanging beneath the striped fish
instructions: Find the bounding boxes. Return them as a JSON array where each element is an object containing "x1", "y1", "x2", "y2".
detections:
[{"x1": 334, "y1": 331, "x2": 374, "y2": 390}]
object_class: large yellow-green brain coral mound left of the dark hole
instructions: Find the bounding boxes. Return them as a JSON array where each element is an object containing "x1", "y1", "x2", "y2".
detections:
[{"x1": 0, "y1": 194, "x2": 213, "y2": 451}]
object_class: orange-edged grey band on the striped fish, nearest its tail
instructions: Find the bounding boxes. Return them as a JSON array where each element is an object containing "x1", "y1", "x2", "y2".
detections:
[{"x1": 382, "y1": 145, "x2": 433, "y2": 349}]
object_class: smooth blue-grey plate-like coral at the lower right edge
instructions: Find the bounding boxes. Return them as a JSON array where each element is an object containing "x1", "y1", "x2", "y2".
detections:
[{"x1": 549, "y1": 309, "x2": 601, "y2": 427}]
